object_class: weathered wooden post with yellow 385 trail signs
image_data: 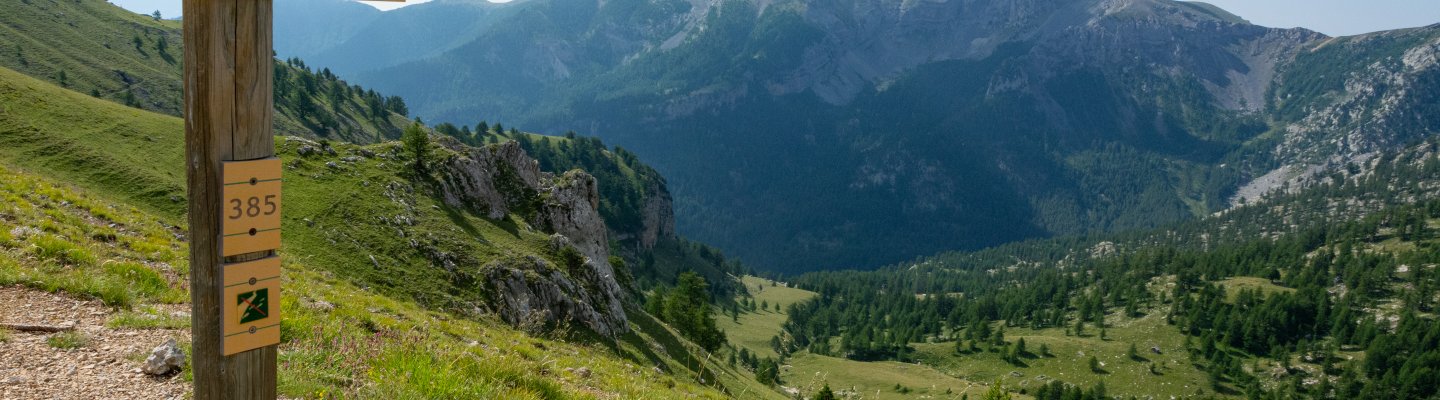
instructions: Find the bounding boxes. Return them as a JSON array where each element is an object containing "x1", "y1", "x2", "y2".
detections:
[{"x1": 183, "y1": 0, "x2": 279, "y2": 400}]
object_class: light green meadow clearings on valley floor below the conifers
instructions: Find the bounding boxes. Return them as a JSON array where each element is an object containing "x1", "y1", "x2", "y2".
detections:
[{"x1": 719, "y1": 276, "x2": 1203, "y2": 399}]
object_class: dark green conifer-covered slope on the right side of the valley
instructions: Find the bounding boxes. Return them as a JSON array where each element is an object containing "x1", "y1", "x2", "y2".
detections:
[{"x1": 780, "y1": 140, "x2": 1440, "y2": 399}]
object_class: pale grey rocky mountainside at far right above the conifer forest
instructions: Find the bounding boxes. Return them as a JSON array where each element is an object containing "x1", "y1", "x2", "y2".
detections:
[{"x1": 1231, "y1": 26, "x2": 1440, "y2": 207}]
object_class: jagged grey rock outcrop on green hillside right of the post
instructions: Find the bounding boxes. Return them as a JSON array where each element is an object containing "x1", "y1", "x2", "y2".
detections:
[{"x1": 441, "y1": 140, "x2": 628, "y2": 337}]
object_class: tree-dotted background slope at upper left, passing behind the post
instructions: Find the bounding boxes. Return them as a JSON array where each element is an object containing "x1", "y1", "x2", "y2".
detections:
[{"x1": 0, "y1": 0, "x2": 409, "y2": 142}]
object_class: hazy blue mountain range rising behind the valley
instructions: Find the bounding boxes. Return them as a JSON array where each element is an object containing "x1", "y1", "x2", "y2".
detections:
[{"x1": 276, "y1": 0, "x2": 1436, "y2": 272}]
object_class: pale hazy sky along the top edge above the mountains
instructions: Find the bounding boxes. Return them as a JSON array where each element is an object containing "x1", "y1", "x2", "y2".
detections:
[{"x1": 111, "y1": 0, "x2": 1440, "y2": 36}]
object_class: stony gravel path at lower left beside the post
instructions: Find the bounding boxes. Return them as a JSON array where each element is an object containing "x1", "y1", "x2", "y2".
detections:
[{"x1": 0, "y1": 286, "x2": 190, "y2": 400}]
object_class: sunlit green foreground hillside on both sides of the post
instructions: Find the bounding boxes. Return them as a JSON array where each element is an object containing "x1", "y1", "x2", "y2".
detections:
[{"x1": 0, "y1": 63, "x2": 778, "y2": 399}]
